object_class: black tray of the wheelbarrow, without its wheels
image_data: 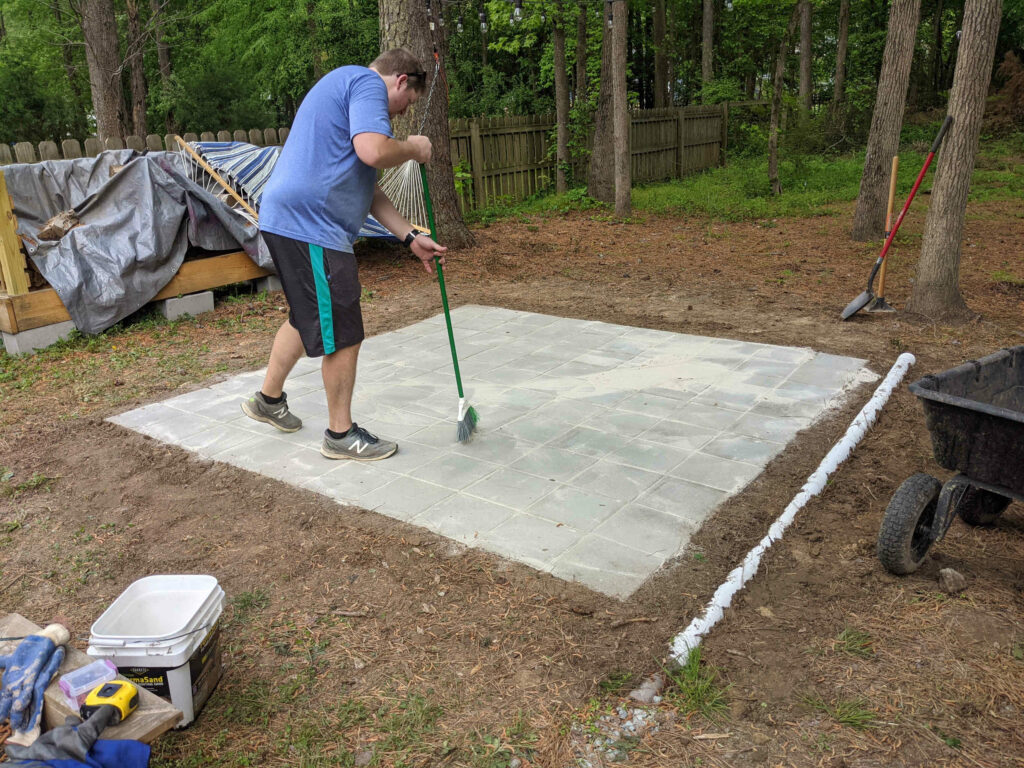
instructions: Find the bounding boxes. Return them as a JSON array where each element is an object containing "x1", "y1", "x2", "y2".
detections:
[{"x1": 909, "y1": 346, "x2": 1024, "y2": 495}]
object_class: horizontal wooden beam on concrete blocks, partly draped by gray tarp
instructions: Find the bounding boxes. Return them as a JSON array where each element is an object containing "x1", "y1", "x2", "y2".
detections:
[{"x1": 0, "y1": 251, "x2": 271, "y2": 334}]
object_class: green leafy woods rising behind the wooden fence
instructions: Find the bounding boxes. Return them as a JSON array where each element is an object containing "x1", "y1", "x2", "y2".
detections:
[{"x1": 0, "y1": 0, "x2": 1024, "y2": 157}]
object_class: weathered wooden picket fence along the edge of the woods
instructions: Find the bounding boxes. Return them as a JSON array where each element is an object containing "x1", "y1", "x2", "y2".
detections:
[{"x1": 0, "y1": 104, "x2": 729, "y2": 211}]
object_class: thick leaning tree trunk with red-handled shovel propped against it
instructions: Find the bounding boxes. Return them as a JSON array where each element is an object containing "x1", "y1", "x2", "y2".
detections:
[{"x1": 906, "y1": 0, "x2": 1002, "y2": 322}]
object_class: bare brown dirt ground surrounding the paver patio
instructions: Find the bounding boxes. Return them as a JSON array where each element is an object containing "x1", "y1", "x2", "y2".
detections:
[{"x1": 0, "y1": 195, "x2": 1024, "y2": 768}]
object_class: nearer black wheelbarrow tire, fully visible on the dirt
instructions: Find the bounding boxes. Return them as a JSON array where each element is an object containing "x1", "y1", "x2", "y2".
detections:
[{"x1": 877, "y1": 472, "x2": 942, "y2": 575}]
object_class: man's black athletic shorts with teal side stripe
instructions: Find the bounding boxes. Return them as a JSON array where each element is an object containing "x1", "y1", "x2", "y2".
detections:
[{"x1": 261, "y1": 232, "x2": 365, "y2": 357}]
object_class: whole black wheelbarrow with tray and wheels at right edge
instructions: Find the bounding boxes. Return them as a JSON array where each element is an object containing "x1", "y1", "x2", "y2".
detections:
[{"x1": 878, "y1": 346, "x2": 1024, "y2": 574}]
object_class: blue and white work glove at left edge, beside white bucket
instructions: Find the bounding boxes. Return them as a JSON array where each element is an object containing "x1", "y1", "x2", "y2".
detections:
[{"x1": 0, "y1": 624, "x2": 71, "y2": 745}]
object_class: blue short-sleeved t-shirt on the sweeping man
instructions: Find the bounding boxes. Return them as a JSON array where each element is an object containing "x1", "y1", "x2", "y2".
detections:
[{"x1": 259, "y1": 67, "x2": 394, "y2": 253}]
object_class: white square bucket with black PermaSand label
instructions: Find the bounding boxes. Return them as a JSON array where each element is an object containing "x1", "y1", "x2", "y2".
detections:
[{"x1": 87, "y1": 575, "x2": 224, "y2": 728}]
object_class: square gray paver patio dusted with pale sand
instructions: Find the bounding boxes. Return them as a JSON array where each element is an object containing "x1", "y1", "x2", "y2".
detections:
[{"x1": 111, "y1": 305, "x2": 878, "y2": 597}]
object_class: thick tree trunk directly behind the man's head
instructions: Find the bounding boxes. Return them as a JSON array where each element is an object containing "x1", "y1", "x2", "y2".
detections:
[{"x1": 379, "y1": 0, "x2": 476, "y2": 248}]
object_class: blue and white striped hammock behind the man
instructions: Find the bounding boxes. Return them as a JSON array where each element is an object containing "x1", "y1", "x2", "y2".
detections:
[{"x1": 181, "y1": 141, "x2": 419, "y2": 239}]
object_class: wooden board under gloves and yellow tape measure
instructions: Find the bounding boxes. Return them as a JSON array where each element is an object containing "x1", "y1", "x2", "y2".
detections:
[{"x1": 0, "y1": 613, "x2": 181, "y2": 743}]
